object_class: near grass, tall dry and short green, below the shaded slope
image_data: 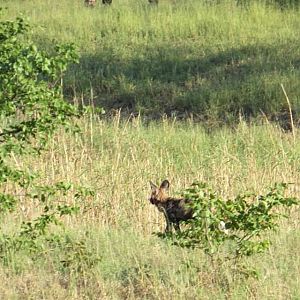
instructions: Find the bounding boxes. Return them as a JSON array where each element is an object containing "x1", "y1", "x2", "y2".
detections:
[{"x1": 0, "y1": 117, "x2": 300, "y2": 299}]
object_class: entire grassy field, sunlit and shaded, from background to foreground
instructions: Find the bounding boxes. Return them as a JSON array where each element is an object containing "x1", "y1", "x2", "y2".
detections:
[{"x1": 0, "y1": 0, "x2": 300, "y2": 300}]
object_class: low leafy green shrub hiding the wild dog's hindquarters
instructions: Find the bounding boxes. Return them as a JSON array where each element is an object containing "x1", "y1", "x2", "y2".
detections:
[{"x1": 159, "y1": 183, "x2": 298, "y2": 259}]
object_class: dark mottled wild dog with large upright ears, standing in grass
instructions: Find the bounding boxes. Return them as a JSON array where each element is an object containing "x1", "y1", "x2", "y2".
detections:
[{"x1": 149, "y1": 180, "x2": 193, "y2": 232}]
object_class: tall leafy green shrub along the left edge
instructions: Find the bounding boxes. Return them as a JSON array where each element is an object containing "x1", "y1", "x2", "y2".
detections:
[{"x1": 0, "y1": 12, "x2": 93, "y2": 260}]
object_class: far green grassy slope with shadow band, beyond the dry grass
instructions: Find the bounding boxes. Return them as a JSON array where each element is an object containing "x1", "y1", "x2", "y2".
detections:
[{"x1": 5, "y1": 0, "x2": 300, "y2": 119}]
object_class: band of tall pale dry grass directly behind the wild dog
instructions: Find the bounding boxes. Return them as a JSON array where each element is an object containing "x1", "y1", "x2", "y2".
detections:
[{"x1": 12, "y1": 113, "x2": 300, "y2": 234}]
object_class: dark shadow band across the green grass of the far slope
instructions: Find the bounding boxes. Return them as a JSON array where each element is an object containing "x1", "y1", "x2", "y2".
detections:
[{"x1": 66, "y1": 41, "x2": 300, "y2": 120}]
